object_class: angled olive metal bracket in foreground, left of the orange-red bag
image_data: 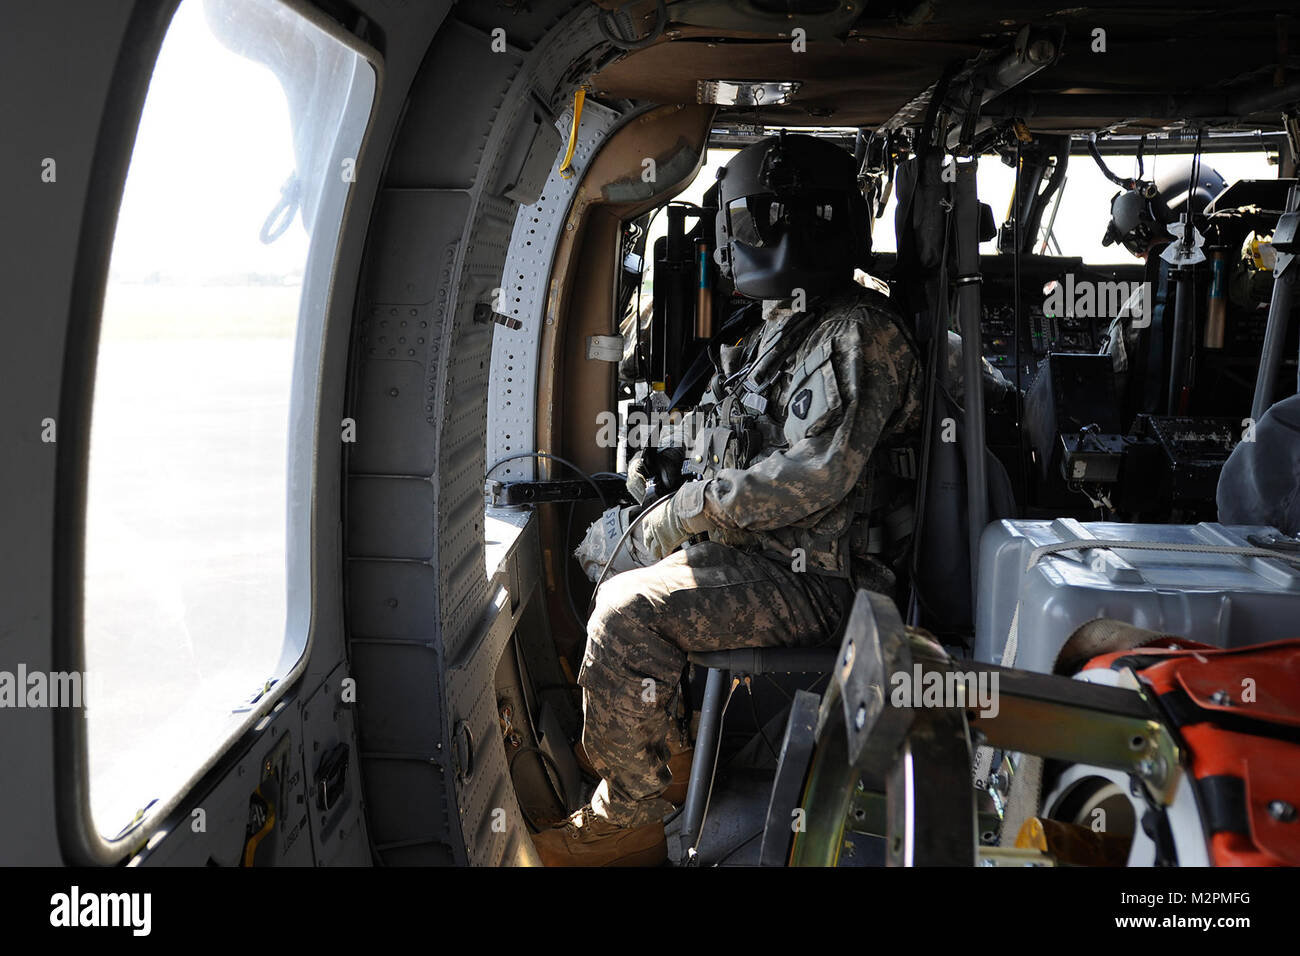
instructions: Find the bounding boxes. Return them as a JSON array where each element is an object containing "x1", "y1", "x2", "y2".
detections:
[{"x1": 790, "y1": 591, "x2": 1182, "y2": 866}]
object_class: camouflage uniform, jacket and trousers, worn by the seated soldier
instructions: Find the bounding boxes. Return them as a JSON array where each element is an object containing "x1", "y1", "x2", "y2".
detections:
[{"x1": 579, "y1": 286, "x2": 922, "y2": 826}]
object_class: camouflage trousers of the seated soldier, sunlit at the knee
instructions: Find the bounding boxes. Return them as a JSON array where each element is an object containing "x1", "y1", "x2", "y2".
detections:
[{"x1": 577, "y1": 541, "x2": 853, "y2": 826}]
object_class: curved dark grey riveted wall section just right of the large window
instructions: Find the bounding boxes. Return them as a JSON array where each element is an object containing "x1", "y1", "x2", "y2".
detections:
[{"x1": 346, "y1": 0, "x2": 614, "y2": 864}]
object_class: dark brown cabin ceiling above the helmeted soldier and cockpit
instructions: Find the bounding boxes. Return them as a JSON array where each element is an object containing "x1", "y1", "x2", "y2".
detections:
[{"x1": 592, "y1": 0, "x2": 1300, "y2": 133}]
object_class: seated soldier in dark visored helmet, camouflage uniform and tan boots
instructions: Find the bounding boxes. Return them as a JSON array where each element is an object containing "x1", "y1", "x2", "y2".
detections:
[{"x1": 533, "y1": 135, "x2": 923, "y2": 866}]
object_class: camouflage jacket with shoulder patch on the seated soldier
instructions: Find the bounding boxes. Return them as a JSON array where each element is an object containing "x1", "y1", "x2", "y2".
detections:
[{"x1": 667, "y1": 285, "x2": 922, "y2": 576}]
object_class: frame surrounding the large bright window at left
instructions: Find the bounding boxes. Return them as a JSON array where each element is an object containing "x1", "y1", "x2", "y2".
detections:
[{"x1": 53, "y1": 0, "x2": 384, "y2": 865}]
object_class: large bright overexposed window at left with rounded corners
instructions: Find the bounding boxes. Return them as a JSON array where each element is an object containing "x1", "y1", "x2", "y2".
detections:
[{"x1": 83, "y1": 0, "x2": 376, "y2": 838}]
